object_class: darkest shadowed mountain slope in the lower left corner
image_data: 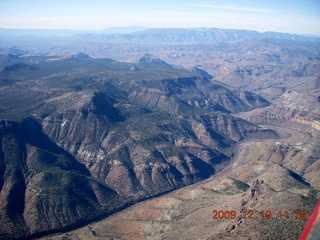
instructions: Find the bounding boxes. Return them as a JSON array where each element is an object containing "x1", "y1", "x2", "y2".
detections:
[{"x1": 0, "y1": 119, "x2": 124, "y2": 239}]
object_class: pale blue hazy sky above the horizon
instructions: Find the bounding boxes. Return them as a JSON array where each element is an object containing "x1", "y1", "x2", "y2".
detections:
[{"x1": 0, "y1": 0, "x2": 320, "y2": 35}]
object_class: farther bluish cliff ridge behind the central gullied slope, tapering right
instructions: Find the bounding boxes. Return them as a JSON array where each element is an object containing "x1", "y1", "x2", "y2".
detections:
[{"x1": 129, "y1": 77, "x2": 269, "y2": 114}]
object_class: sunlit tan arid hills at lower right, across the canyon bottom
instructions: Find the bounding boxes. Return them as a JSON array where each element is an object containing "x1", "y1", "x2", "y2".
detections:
[{"x1": 45, "y1": 121, "x2": 319, "y2": 240}]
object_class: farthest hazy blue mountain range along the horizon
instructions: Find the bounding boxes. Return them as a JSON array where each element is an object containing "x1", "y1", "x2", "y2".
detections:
[{"x1": 0, "y1": 27, "x2": 317, "y2": 43}]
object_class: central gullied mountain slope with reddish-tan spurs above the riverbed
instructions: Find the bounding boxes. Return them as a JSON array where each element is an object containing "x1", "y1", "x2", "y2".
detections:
[{"x1": 42, "y1": 90, "x2": 258, "y2": 198}]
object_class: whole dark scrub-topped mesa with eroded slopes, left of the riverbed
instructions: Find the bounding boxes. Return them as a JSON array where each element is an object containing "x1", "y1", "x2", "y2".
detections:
[{"x1": 0, "y1": 54, "x2": 277, "y2": 239}]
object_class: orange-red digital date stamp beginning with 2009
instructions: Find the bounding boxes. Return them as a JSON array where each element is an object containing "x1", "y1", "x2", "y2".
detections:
[{"x1": 212, "y1": 209, "x2": 309, "y2": 220}]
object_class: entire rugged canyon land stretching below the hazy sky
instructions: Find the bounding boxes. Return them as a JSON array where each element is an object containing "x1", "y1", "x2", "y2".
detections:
[{"x1": 0, "y1": 29, "x2": 320, "y2": 239}]
